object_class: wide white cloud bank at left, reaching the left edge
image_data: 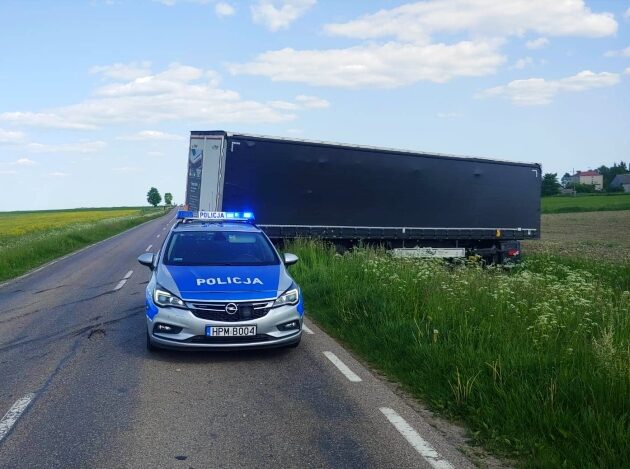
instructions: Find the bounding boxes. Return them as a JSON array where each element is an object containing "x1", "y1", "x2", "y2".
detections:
[{"x1": 0, "y1": 64, "x2": 312, "y2": 129}]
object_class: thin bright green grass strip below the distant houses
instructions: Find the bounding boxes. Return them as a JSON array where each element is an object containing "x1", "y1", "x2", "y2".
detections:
[{"x1": 541, "y1": 194, "x2": 630, "y2": 213}]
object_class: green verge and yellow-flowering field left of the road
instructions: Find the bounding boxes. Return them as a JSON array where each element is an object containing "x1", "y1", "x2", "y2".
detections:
[{"x1": 0, "y1": 208, "x2": 166, "y2": 281}]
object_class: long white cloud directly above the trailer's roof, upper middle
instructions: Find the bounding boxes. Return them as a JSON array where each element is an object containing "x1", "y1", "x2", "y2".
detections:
[{"x1": 228, "y1": 41, "x2": 505, "y2": 88}]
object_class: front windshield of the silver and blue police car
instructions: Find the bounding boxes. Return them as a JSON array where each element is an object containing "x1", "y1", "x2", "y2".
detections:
[{"x1": 164, "y1": 231, "x2": 280, "y2": 266}]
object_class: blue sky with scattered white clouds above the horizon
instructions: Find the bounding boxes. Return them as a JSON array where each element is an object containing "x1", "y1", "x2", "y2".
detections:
[{"x1": 0, "y1": 0, "x2": 630, "y2": 211}]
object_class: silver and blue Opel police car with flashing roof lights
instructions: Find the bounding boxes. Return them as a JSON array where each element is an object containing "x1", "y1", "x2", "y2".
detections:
[{"x1": 138, "y1": 211, "x2": 304, "y2": 350}]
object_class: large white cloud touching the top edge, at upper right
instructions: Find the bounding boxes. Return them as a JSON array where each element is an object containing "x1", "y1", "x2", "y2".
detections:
[{"x1": 325, "y1": 0, "x2": 617, "y2": 42}]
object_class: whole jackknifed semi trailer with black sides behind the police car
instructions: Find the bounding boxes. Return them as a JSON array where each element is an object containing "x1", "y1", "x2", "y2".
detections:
[{"x1": 186, "y1": 130, "x2": 542, "y2": 262}]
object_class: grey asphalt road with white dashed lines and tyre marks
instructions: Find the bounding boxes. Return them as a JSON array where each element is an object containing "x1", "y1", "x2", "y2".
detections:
[{"x1": 0, "y1": 215, "x2": 471, "y2": 469}]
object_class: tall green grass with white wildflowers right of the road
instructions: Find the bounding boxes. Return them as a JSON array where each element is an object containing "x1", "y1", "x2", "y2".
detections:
[{"x1": 290, "y1": 242, "x2": 630, "y2": 467}]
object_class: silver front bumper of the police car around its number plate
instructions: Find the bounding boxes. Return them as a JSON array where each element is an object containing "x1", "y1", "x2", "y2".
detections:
[{"x1": 147, "y1": 305, "x2": 303, "y2": 350}]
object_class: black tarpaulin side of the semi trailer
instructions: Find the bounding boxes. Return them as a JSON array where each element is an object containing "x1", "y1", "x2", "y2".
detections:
[{"x1": 193, "y1": 132, "x2": 541, "y2": 243}]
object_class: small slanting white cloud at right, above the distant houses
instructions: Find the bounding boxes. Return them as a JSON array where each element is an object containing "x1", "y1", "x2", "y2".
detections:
[{"x1": 477, "y1": 70, "x2": 620, "y2": 106}]
